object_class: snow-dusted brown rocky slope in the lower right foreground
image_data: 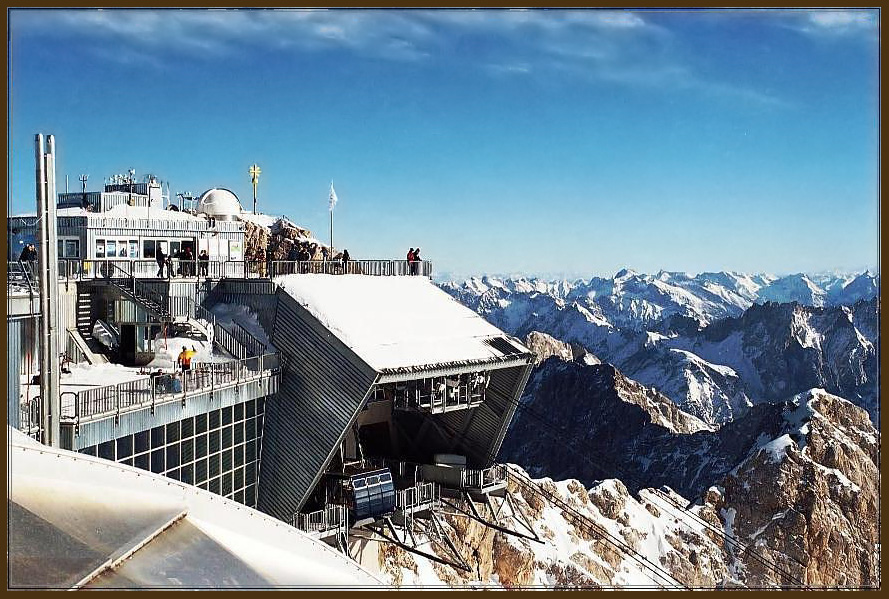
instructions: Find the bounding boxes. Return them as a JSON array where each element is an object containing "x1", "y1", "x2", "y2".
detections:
[{"x1": 368, "y1": 386, "x2": 880, "y2": 588}]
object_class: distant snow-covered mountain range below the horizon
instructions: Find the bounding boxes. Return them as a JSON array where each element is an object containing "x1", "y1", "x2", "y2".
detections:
[{"x1": 441, "y1": 269, "x2": 880, "y2": 424}]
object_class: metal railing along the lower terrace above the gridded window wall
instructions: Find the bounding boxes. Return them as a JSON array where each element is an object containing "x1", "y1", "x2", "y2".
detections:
[{"x1": 62, "y1": 354, "x2": 280, "y2": 423}]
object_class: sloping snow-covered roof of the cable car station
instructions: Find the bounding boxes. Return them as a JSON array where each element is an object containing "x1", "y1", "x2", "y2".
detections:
[{"x1": 274, "y1": 274, "x2": 530, "y2": 372}]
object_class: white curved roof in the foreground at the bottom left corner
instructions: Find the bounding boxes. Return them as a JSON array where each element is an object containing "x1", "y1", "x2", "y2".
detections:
[{"x1": 7, "y1": 427, "x2": 383, "y2": 589}]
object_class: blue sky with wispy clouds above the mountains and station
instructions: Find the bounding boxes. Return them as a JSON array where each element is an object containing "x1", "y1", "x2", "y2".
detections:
[{"x1": 7, "y1": 10, "x2": 880, "y2": 277}]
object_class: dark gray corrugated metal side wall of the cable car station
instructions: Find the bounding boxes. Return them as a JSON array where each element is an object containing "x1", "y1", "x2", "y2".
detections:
[{"x1": 259, "y1": 291, "x2": 377, "y2": 519}]
